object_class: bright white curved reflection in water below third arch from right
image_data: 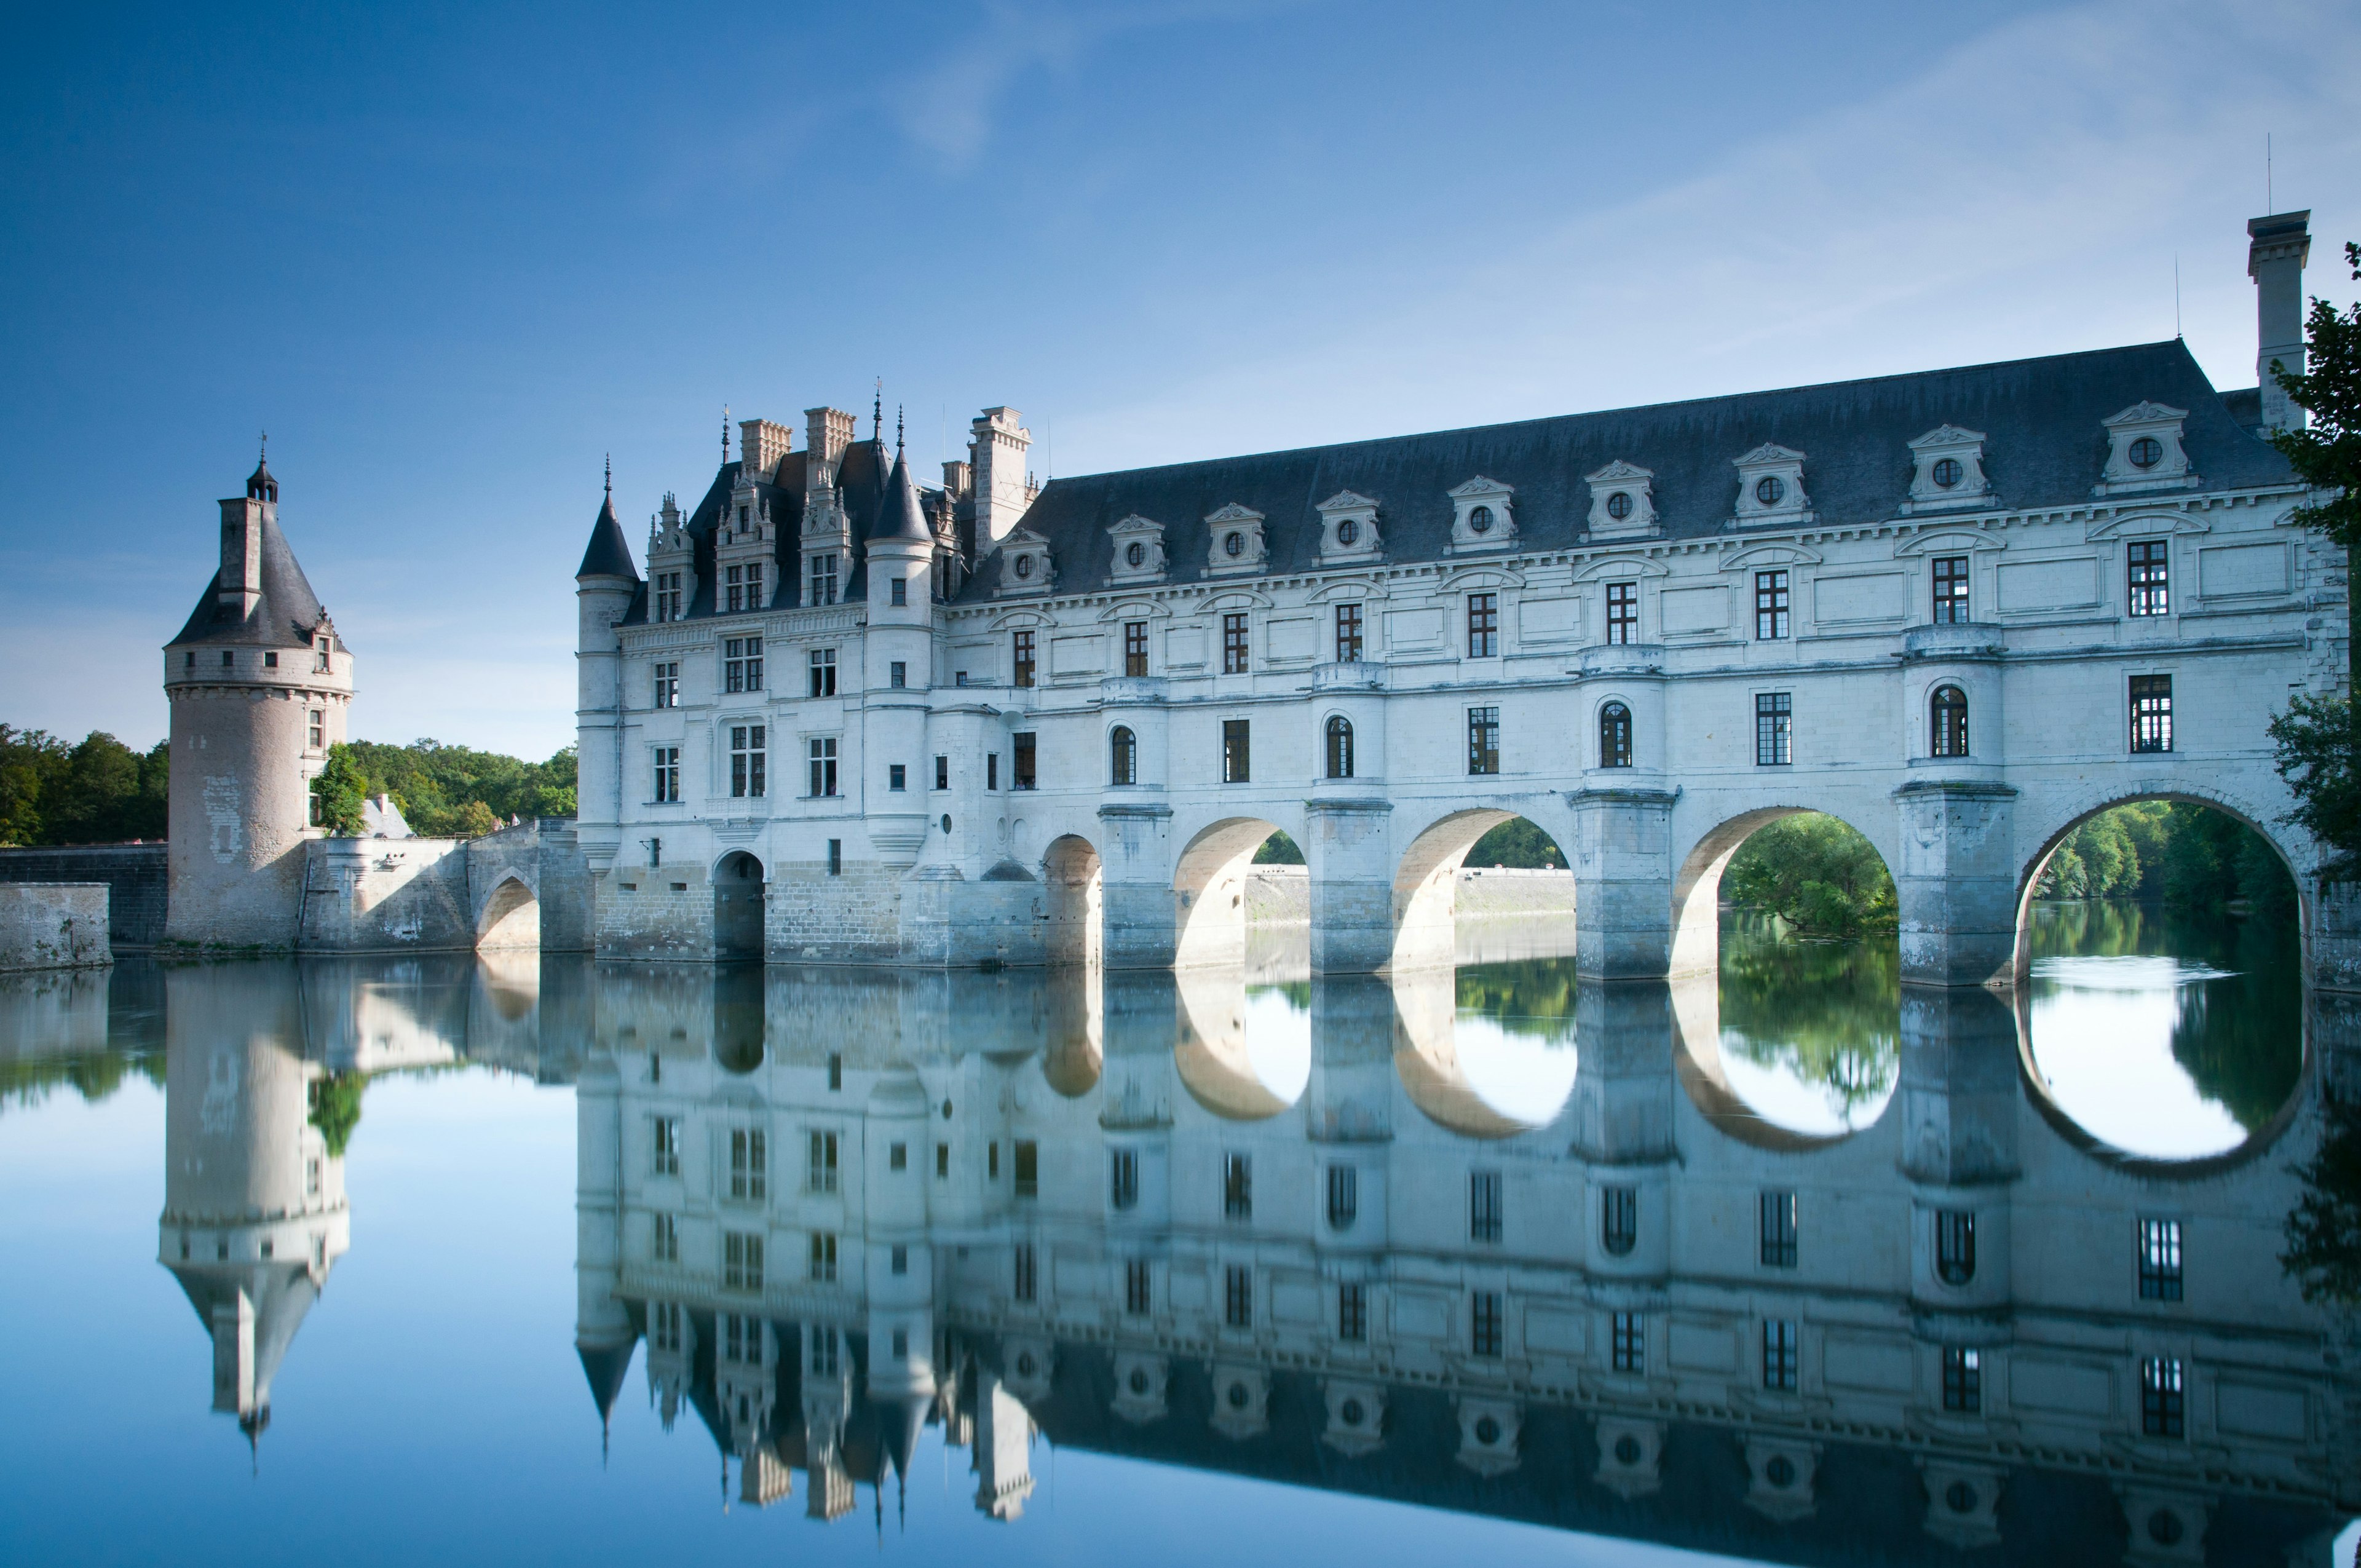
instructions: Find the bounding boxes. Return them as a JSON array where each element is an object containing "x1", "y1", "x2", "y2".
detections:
[{"x1": 1393, "y1": 970, "x2": 1580, "y2": 1138}]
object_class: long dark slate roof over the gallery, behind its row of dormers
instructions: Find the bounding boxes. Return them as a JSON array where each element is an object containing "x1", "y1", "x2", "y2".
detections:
[{"x1": 961, "y1": 340, "x2": 2295, "y2": 600}]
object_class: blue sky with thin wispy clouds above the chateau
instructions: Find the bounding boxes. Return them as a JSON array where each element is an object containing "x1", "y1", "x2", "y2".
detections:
[{"x1": 0, "y1": 0, "x2": 2361, "y2": 756}]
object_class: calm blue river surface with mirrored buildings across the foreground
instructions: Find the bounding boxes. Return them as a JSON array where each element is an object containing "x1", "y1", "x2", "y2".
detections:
[{"x1": 0, "y1": 907, "x2": 2361, "y2": 1566}]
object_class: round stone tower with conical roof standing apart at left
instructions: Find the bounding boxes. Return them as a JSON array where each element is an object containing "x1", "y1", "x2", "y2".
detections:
[{"x1": 163, "y1": 463, "x2": 352, "y2": 947}]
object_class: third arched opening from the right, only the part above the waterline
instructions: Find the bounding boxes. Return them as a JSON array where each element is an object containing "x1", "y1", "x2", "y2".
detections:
[{"x1": 1388, "y1": 807, "x2": 1575, "y2": 970}]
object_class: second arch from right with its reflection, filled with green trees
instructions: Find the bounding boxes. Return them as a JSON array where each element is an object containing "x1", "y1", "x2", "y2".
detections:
[{"x1": 1674, "y1": 807, "x2": 1900, "y2": 1147}]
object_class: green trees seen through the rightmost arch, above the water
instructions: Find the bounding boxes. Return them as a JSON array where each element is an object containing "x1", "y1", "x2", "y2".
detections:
[{"x1": 2035, "y1": 801, "x2": 2295, "y2": 916}]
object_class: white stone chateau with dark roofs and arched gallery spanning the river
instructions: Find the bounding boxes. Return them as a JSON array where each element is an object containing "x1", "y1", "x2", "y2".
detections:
[{"x1": 576, "y1": 213, "x2": 2344, "y2": 983}]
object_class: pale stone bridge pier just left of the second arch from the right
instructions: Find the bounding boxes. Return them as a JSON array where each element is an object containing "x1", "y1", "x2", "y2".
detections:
[{"x1": 1568, "y1": 789, "x2": 1679, "y2": 980}]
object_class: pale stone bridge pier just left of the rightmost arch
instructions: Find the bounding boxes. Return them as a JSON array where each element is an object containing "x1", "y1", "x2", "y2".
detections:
[{"x1": 1894, "y1": 779, "x2": 2016, "y2": 984}]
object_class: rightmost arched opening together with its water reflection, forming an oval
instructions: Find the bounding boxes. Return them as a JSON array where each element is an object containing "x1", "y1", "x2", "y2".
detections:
[{"x1": 2016, "y1": 796, "x2": 2304, "y2": 1162}]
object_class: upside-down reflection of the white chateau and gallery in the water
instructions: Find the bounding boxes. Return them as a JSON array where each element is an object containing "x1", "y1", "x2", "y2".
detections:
[{"x1": 579, "y1": 968, "x2": 2361, "y2": 1563}]
